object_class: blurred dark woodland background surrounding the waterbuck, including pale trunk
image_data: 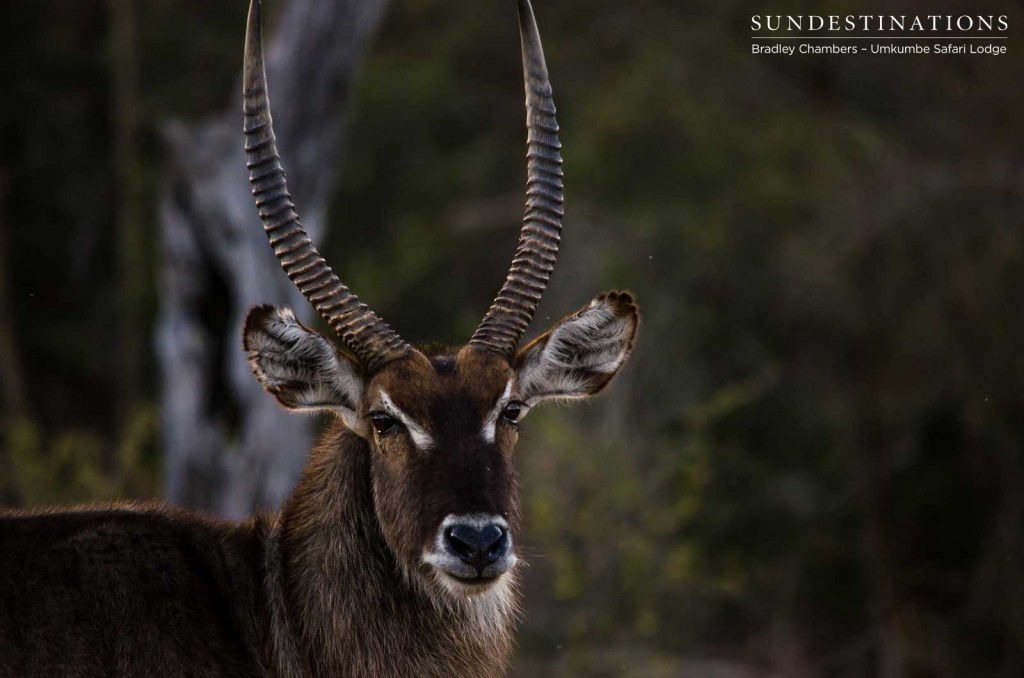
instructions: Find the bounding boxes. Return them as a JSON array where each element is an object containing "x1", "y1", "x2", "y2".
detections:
[{"x1": 0, "y1": 0, "x2": 1024, "y2": 678}]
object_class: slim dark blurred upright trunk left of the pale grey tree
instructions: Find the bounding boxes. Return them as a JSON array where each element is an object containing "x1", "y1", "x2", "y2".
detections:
[{"x1": 108, "y1": 0, "x2": 150, "y2": 444}]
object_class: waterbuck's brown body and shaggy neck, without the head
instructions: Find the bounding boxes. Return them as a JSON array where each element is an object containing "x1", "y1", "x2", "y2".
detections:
[{"x1": 0, "y1": 425, "x2": 514, "y2": 678}]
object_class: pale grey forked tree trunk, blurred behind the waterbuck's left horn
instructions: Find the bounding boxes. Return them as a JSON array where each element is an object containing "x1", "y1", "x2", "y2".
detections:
[{"x1": 157, "y1": 0, "x2": 386, "y2": 516}]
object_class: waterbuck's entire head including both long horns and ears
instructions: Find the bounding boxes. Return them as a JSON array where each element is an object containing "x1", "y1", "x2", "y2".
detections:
[{"x1": 245, "y1": 0, "x2": 639, "y2": 597}]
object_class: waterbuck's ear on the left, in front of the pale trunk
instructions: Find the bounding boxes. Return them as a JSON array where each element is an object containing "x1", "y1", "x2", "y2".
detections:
[{"x1": 243, "y1": 306, "x2": 362, "y2": 428}]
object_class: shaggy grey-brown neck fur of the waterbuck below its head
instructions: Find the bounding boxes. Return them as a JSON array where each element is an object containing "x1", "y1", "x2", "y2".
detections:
[{"x1": 267, "y1": 424, "x2": 516, "y2": 678}]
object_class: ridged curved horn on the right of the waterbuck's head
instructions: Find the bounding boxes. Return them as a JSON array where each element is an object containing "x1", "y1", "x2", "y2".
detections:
[{"x1": 469, "y1": 0, "x2": 562, "y2": 359}]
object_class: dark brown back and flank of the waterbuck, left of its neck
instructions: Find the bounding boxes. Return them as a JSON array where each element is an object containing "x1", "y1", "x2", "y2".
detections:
[{"x1": 0, "y1": 505, "x2": 270, "y2": 678}]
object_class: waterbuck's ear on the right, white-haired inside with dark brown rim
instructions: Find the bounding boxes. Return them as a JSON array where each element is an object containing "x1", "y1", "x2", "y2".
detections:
[{"x1": 514, "y1": 292, "x2": 640, "y2": 407}]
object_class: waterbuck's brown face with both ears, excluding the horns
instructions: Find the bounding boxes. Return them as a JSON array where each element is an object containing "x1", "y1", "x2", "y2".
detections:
[{"x1": 244, "y1": 293, "x2": 638, "y2": 596}]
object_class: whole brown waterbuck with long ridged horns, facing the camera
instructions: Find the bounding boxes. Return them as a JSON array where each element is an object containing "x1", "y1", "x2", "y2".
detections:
[{"x1": 0, "y1": 0, "x2": 638, "y2": 678}]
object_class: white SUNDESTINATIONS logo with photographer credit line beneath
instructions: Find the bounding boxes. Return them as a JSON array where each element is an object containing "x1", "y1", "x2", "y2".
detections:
[{"x1": 750, "y1": 14, "x2": 1010, "y2": 56}]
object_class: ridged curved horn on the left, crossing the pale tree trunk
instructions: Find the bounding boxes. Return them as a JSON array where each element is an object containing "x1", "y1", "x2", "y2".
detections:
[{"x1": 243, "y1": 0, "x2": 411, "y2": 372}]
